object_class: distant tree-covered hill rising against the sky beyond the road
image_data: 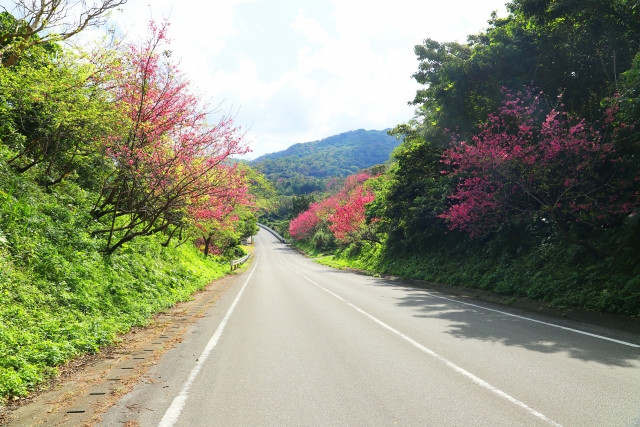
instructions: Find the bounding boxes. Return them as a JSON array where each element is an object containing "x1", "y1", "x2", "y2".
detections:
[{"x1": 250, "y1": 129, "x2": 399, "y2": 193}]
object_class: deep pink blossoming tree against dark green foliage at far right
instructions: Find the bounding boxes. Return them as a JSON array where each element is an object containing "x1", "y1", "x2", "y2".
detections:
[{"x1": 441, "y1": 88, "x2": 640, "y2": 252}]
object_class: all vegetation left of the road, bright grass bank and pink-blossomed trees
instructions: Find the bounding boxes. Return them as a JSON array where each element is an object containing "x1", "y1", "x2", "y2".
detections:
[{"x1": 0, "y1": 0, "x2": 264, "y2": 399}]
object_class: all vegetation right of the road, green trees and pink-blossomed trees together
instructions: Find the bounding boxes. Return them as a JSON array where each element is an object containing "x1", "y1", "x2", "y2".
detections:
[{"x1": 267, "y1": 0, "x2": 640, "y2": 316}]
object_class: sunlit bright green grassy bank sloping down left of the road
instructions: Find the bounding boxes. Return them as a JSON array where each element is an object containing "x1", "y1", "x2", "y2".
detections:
[{"x1": 0, "y1": 162, "x2": 235, "y2": 398}]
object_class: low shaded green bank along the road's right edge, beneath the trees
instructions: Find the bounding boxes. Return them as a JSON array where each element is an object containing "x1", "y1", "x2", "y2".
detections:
[{"x1": 295, "y1": 231, "x2": 640, "y2": 317}]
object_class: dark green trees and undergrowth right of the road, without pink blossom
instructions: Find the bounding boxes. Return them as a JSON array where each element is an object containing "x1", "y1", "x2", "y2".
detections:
[{"x1": 284, "y1": 0, "x2": 640, "y2": 316}]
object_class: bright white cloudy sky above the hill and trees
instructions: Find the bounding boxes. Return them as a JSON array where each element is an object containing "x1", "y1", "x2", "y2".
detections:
[{"x1": 0, "y1": 0, "x2": 507, "y2": 158}]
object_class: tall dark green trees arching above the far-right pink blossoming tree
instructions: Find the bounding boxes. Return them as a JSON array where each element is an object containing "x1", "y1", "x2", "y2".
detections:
[{"x1": 382, "y1": 0, "x2": 640, "y2": 251}]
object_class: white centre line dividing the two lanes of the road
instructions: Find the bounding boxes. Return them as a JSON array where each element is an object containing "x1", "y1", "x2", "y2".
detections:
[{"x1": 278, "y1": 257, "x2": 562, "y2": 427}]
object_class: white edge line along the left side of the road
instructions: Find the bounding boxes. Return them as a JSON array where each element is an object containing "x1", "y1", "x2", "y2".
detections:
[{"x1": 158, "y1": 258, "x2": 258, "y2": 427}]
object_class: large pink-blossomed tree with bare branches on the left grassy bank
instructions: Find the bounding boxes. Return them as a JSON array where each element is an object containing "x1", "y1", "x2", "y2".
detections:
[{"x1": 92, "y1": 22, "x2": 249, "y2": 253}]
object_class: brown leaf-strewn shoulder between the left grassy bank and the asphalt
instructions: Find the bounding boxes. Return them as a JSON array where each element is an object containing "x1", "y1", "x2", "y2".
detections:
[{"x1": 0, "y1": 257, "x2": 252, "y2": 427}]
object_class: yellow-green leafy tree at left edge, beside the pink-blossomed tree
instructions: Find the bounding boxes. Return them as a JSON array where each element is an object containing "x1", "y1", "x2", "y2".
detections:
[{"x1": 0, "y1": 45, "x2": 121, "y2": 188}]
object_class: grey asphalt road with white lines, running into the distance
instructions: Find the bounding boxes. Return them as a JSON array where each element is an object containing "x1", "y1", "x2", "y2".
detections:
[{"x1": 99, "y1": 230, "x2": 640, "y2": 427}]
